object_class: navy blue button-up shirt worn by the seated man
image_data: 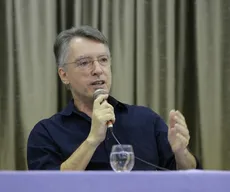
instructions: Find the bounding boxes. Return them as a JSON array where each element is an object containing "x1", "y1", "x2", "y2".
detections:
[{"x1": 27, "y1": 96, "x2": 200, "y2": 170}]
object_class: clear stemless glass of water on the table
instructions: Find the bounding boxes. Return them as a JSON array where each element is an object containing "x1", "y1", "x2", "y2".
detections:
[{"x1": 110, "y1": 145, "x2": 135, "y2": 172}]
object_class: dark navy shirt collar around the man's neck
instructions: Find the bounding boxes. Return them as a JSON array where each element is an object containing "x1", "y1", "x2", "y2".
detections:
[{"x1": 59, "y1": 96, "x2": 127, "y2": 116}]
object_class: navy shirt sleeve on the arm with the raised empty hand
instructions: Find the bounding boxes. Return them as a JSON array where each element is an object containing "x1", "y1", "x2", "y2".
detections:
[{"x1": 155, "y1": 114, "x2": 202, "y2": 170}]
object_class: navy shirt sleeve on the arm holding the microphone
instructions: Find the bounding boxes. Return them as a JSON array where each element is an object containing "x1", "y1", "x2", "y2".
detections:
[{"x1": 27, "y1": 122, "x2": 62, "y2": 170}]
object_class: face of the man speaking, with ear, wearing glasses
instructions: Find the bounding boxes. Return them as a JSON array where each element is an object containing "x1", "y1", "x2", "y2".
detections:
[{"x1": 59, "y1": 37, "x2": 112, "y2": 100}]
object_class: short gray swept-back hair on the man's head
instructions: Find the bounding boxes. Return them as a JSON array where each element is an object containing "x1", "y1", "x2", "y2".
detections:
[{"x1": 53, "y1": 25, "x2": 108, "y2": 67}]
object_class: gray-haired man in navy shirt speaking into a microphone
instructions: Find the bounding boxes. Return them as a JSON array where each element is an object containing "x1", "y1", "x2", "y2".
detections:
[{"x1": 27, "y1": 26, "x2": 200, "y2": 170}]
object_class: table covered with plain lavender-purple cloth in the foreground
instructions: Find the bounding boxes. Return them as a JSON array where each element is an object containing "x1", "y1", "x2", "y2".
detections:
[{"x1": 0, "y1": 170, "x2": 230, "y2": 192}]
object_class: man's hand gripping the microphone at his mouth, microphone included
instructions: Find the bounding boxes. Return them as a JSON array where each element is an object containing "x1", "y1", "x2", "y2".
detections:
[{"x1": 88, "y1": 90, "x2": 115, "y2": 145}]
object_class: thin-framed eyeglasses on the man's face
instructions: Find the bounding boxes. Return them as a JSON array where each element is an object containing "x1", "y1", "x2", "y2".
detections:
[{"x1": 64, "y1": 55, "x2": 111, "y2": 69}]
